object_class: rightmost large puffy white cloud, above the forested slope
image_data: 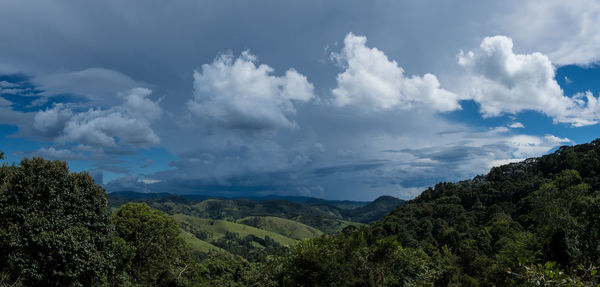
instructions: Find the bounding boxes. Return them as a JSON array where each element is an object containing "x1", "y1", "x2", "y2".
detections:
[{"x1": 458, "y1": 36, "x2": 600, "y2": 126}]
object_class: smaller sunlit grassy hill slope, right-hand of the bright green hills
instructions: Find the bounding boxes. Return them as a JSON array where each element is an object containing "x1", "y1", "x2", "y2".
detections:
[{"x1": 237, "y1": 216, "x2": 323, "y2": 240}]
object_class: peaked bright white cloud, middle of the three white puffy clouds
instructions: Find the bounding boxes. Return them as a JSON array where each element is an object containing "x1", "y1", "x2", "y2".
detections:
[{"x1": 332, "y1": 33, "x2": 460, "y2": 112}]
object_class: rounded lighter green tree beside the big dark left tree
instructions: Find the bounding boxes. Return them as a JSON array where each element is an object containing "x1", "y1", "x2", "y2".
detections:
[{"x1": 113, "y1": 203, "x2": 190, "y2": 286}]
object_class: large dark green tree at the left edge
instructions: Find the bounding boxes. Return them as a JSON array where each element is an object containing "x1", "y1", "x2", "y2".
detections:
[{"x1": 0, "y1": 158, "x2": 113, "y2": 286}]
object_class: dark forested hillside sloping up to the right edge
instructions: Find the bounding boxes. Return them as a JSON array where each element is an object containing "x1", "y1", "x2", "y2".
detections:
[{"x1": 369, "y1": 140, "x2": 600, "y2": 286}]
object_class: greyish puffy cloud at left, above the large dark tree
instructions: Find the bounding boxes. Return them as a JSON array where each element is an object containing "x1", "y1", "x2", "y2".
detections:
[{"x1": 34, "y1": 88, "x2": 162, "y2": 147}]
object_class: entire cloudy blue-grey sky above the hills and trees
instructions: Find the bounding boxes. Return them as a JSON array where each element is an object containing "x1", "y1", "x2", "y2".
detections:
[{"x1": 0, "y1": 0, "x2": 600, "y2": 200}]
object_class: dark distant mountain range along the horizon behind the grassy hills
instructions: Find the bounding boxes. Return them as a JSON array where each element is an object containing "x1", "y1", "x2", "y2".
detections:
[{"x1": 108, "y1": 192, "x2": 405, "y2": 228}]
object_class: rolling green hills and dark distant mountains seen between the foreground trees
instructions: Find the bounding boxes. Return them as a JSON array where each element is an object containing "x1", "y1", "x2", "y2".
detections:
[{"x1": 108, "y1": 191, "x2": 405, "y2": 261}]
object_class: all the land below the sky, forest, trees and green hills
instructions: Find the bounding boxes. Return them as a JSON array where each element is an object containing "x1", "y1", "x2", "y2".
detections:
[{"x1": 5, "y1": 140, "x2": 600, "y2": 286}]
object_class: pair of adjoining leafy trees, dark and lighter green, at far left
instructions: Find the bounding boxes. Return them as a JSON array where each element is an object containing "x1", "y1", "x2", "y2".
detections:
[{"x1": 0, "y1": 158, "x2": 190, "y2": 286}]
